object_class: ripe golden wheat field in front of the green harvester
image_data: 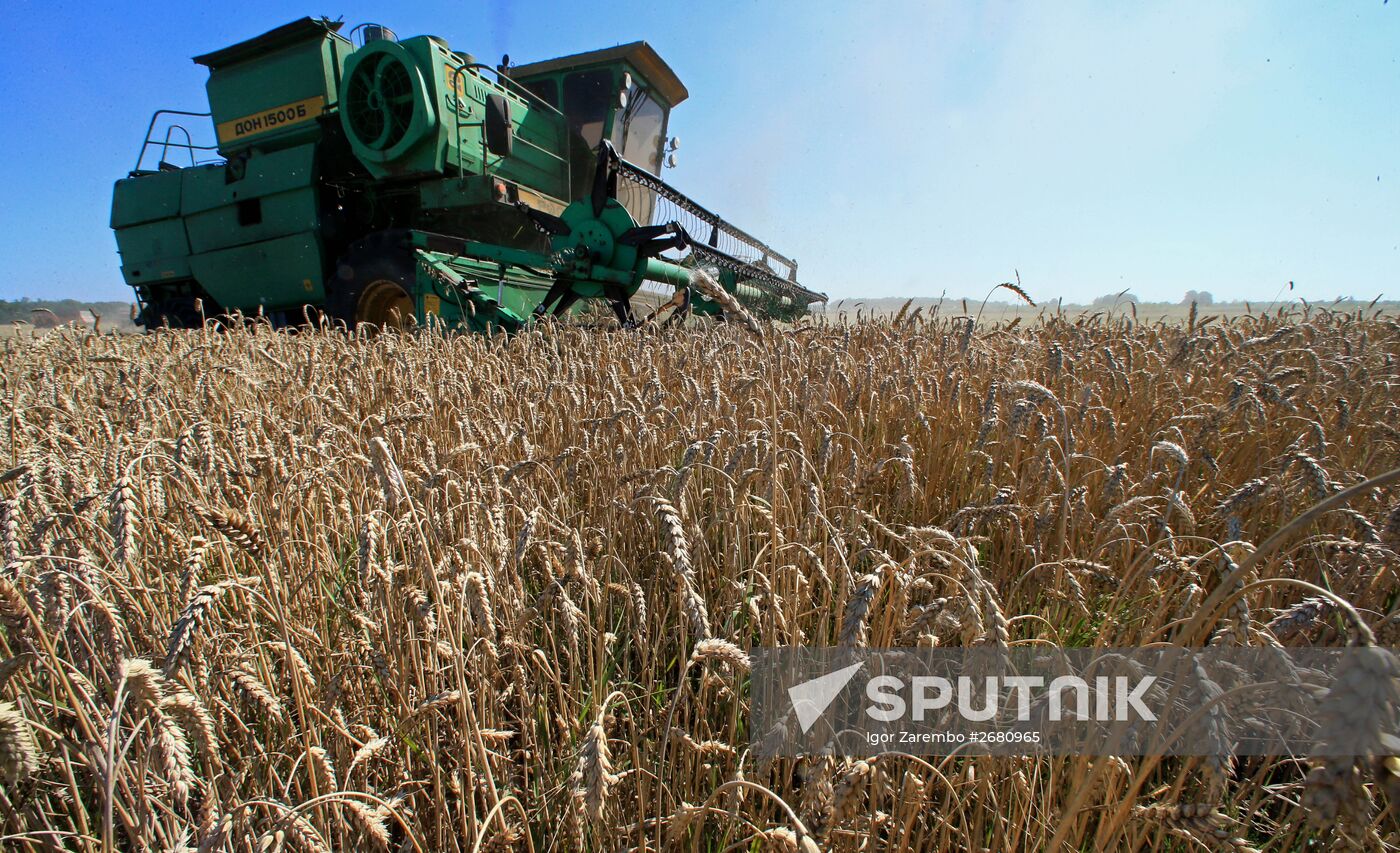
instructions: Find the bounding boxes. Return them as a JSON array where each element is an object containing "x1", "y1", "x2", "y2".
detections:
[{"x1": 0, "y1": 310, "x2": 1400, "y2": 853}]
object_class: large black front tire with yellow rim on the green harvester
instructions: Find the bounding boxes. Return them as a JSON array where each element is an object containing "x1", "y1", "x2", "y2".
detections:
[{"x1": 326, "y1": 231, "x2": 417, "y2": 329}]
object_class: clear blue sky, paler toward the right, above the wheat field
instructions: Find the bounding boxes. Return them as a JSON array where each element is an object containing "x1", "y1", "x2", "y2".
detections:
[{"x1": 0, "y1": 0, "x2": 1400, "y2": 303}]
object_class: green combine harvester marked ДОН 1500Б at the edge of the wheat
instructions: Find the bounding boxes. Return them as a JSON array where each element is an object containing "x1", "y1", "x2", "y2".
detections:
[{"x1": 112, "y1": 18, "x2": 826, "y2": 331}]
